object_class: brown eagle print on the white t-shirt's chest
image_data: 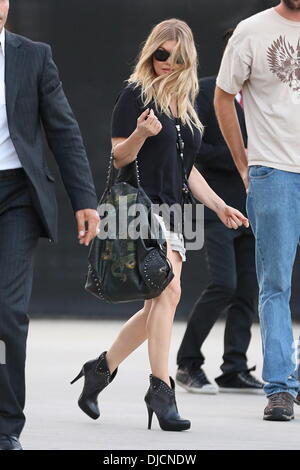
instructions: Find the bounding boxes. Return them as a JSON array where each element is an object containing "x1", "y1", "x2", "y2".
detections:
[{"x1": 267, "y1": 36, "x2": 300, "y2": 104}]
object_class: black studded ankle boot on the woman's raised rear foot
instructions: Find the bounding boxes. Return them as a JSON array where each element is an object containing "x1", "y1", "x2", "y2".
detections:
[{"x1": 71, "y1": 351, "x2": 118, "y2": 419}]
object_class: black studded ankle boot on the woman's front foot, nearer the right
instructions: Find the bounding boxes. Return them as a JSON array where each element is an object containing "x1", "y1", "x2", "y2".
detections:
[{"x1": 145, "y1": 374, "x2": 191, "y2": 431}]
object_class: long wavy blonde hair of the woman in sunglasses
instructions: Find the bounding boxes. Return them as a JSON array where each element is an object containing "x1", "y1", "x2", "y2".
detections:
[{"x1": 128, "y1": 18, "x2": 203, "y2": 132}]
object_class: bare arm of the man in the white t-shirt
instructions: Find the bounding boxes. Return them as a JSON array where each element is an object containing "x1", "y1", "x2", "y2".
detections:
[{"x1": 214, "y1": 86, "x2": 248, "y2": 189}]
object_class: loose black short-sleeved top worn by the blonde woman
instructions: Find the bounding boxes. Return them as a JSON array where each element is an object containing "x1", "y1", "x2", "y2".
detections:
[{"x1": 111, "y1": 84, "x2": 201, "y2": 232}]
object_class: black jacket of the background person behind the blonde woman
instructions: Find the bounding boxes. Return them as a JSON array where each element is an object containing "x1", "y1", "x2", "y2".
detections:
[{"x1": 196, "y1": 76, "x2": 247, "y2": 220}]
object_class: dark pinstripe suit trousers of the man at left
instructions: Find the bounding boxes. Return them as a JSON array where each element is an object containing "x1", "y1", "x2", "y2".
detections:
[{"x1": 0, "y1": 170, "x2": 42, "y2": 436}]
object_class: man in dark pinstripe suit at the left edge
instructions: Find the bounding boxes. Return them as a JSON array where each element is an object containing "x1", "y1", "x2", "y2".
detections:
[{"x1": 0, "y1": 0, "x2": 99, "y2": 450}]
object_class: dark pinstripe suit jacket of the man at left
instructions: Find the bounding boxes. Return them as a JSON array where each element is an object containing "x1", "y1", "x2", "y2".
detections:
[{"x1": 5, "y1": 31, "x2": 97, "y2": 241}]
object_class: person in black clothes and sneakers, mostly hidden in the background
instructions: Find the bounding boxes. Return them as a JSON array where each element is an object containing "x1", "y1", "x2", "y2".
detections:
[{"x1": 176, "y1": 30, "x2": 263, "y2": 394}]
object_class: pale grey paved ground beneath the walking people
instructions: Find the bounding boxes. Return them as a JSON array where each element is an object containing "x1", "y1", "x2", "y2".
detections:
[{"x1": 22, "y1": 320, "x2": 300, "y2": 450}]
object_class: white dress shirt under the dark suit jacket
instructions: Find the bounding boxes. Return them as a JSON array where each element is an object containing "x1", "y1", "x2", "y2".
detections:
[{"x1": 0, "y1": 28, "x2": 22, "y2": 171}]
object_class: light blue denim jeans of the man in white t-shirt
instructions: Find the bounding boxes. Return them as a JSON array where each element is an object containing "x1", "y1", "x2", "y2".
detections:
[{"x1": 246, "y1": 165, "x2": 300, "y2": 397}]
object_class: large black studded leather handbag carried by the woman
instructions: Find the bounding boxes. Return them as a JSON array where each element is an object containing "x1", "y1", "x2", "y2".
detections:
[{"x1": 85, "y1": 154, "x2": 174, "y2": 303}]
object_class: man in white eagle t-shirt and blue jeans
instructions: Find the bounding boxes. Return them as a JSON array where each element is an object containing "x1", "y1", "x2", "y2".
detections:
[{"x1": 215, "y1": 0, "x2": 300, "y2": 421}]
